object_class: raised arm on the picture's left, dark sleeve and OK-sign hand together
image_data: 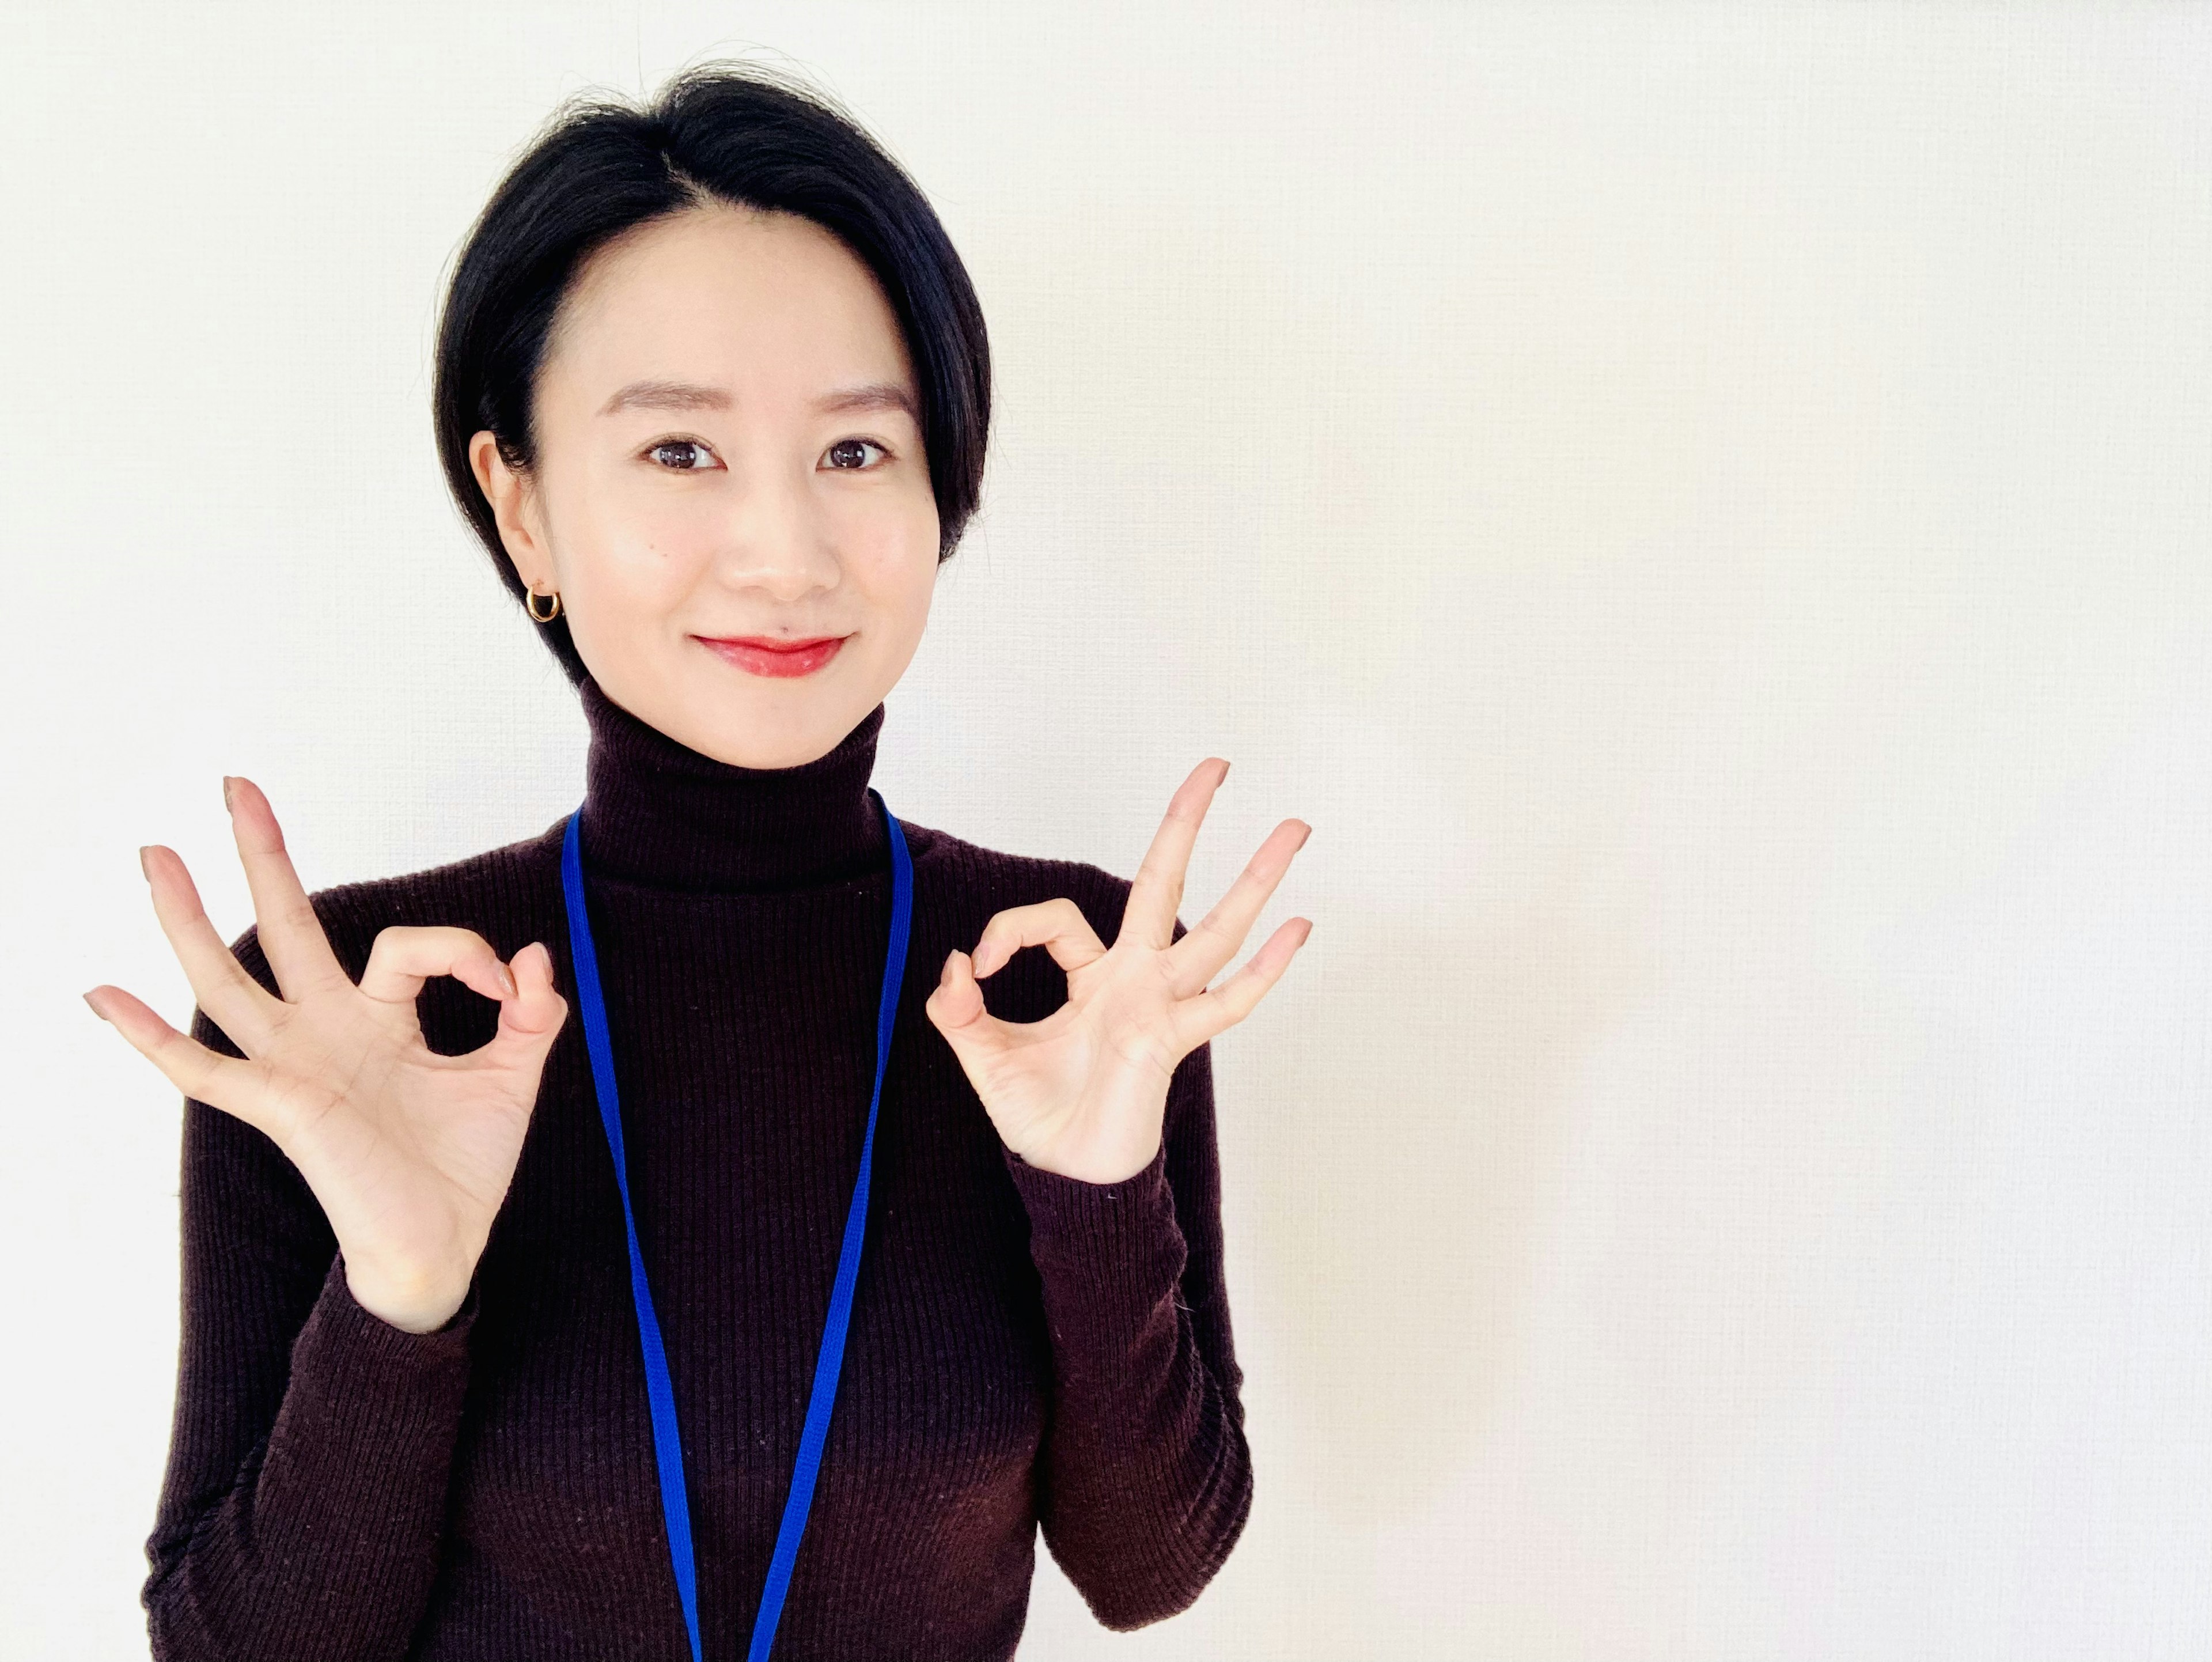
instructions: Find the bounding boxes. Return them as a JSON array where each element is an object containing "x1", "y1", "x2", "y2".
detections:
[{"x1": 86, "y1": 779, "x2": 569, "y2": 1662}]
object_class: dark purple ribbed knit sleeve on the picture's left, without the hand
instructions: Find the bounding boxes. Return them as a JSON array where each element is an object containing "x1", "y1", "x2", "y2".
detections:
[{"x1": 144, "y1": 929, "x2": 476, "y2": 1662}]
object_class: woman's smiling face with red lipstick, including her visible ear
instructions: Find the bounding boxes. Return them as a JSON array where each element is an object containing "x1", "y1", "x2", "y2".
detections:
[{"x1": 469, "y1": 206, "x2": 938, "y2": 768}]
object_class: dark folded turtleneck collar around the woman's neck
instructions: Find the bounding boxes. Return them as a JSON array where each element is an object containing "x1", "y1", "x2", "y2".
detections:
[{"x1": 579, "y1": 679, "x2": 892, "y2": 892}]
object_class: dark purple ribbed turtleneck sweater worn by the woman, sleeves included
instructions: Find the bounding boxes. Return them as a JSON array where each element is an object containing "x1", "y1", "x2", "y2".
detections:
[{"x1": 144, "y1": 682, "x2": 1252, "y2": 1662}]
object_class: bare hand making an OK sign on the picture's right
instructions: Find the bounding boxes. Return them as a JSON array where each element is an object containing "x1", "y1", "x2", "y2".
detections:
[{"x1": 925, "y1": 757, "x2": 1314, "y2": 1184}]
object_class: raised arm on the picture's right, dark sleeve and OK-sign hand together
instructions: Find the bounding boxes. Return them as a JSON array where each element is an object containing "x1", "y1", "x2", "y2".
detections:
[{"x1": 927, "y1": 757, "x2": 1312, "y2": 1629}]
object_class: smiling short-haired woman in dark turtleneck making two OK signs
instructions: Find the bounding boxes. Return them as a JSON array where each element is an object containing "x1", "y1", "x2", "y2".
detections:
[{"x1": 86, "y1": 58, "x2": 1309, "y2": 1662}]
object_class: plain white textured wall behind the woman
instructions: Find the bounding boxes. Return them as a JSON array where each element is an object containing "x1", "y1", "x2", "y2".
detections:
[{"x1": 0, "y1": 0, "x2": 2212, "y2": 1662}]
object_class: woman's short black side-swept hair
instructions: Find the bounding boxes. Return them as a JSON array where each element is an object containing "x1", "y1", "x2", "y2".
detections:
[{"x1": 431, "y1": 62, "x2": 991, "y2": 682}]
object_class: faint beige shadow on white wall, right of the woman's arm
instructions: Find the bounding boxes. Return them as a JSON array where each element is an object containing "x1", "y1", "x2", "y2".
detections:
[{"x1": 1250, "y1": 847, "x2": 1657, "y2": 1530}]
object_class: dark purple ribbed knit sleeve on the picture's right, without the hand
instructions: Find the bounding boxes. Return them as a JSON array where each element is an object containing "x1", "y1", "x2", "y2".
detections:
[{"x1": 1006, "y1": 1035, "x2": 1252, "y2": 1629}]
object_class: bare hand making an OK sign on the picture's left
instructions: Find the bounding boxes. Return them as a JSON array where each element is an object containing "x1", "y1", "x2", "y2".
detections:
[{"x1": 84, "y1": 779, "x2": 569, "y2": 1332}]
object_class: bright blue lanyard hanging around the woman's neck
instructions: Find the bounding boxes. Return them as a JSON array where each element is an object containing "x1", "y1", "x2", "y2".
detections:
[{"x1": 560, "y1": 788, "x2": 914, "y2": 1662}]
